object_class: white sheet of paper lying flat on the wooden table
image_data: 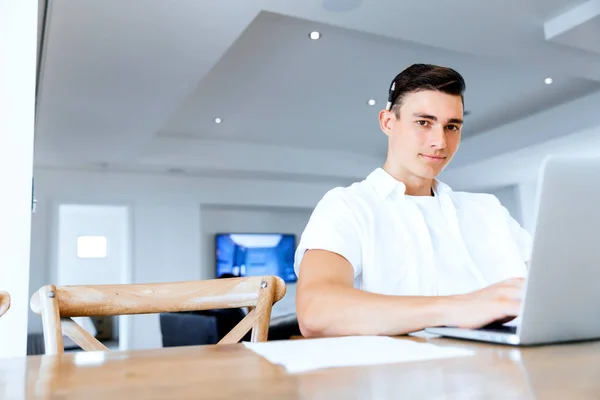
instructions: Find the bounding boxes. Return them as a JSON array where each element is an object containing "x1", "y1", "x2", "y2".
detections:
[{"x1": 244, "y1": 336, "x2": 475, "y2": 373}]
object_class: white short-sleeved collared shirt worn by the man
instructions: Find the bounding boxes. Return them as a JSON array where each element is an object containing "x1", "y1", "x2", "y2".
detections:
[{"x1": 294, "y1": 168, "x2": 532, "y2": 296}]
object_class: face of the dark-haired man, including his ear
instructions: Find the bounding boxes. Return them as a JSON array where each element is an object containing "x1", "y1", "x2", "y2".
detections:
[{"x1": 380, "y1": 90, "x2": 463, "y2": 179}]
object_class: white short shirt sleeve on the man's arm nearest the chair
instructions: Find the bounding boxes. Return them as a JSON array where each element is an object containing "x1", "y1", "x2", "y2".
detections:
[{"x1": 294, "y1": 188, "x2": 362, "y2": 278}]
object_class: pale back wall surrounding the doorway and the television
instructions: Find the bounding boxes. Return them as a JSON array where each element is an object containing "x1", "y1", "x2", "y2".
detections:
[{"x1": 30, "y1": 169, "x2": 335, "y2": 348}]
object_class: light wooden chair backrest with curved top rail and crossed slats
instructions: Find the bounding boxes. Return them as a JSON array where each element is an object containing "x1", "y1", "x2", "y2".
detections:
[{"x1": 31, "y1": 276, "x2": 286, "y2": 354}]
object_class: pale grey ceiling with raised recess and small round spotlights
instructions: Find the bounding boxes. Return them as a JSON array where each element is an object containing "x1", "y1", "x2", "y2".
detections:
[{"x1": 36, "y1": 0, "x2": 600, "y2": 184}]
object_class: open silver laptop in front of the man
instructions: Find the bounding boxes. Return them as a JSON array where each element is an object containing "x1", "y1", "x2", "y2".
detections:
[{"x1": 425, "y1": 156, "x2": 600, "y2": 346}]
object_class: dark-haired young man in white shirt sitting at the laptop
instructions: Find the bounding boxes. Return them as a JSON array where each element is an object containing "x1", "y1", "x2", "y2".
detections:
[{"x1": 295, "y1": 64, "x2": 531, "y2": 336}]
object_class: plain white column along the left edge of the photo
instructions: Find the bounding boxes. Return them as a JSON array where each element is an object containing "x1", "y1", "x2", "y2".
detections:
[{"x1": 0, "y1": 0, "x2": 38, "y2": 357}]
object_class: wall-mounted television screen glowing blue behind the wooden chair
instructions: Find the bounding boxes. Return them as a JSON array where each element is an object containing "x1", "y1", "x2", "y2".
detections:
[{"x1": 215, "y1": 233, "x2": 297, "y2": 283}]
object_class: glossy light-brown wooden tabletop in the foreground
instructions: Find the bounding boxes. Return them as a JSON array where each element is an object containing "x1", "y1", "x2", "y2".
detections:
[{"x1": 0, "y1": 337, "x2": 600, "y2": 400}]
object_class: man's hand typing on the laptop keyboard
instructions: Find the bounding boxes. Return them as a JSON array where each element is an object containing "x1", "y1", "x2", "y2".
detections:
[{"x1": 447, "y1": 278, "x2": 525, "y2": 329}]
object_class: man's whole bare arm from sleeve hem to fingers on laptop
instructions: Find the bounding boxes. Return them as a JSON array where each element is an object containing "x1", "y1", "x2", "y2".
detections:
[{"x1": 296, "y1": 250, "x2": 523, "y2": 337}]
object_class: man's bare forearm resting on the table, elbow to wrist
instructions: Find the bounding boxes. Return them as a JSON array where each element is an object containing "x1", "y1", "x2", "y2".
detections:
[{"x1": 298, "y1": 285, "x2": 455, "y2": 336}]
